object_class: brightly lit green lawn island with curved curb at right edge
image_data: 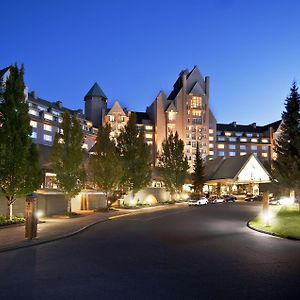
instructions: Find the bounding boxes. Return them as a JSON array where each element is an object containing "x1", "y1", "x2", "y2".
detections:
[{"x1": 249, "y1": 205, "x2": 300, "y2": 239}]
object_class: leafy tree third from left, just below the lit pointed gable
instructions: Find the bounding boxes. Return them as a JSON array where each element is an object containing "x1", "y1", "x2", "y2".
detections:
[{"x1": 91, "y1": 124, "x2": 123, "y2": 207}]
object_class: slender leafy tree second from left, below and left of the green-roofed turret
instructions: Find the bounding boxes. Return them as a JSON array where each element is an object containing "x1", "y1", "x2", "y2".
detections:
[{"x1": 51, "y1": 111, "x2": 85, "y2": 213}]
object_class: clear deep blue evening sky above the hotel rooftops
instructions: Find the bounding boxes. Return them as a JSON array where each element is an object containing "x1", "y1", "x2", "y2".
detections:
[{"x1": 0, "y1": 0, "x2": 300, "y2": 125}]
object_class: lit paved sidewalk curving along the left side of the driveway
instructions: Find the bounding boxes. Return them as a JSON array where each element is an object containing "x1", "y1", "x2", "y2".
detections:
[{"x1": 0, "y1": 204, "x2": 188, "y2": 253}]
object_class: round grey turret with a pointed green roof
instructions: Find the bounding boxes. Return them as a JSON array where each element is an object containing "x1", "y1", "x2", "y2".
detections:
[{"x1": 84, "y1": 82, "x2": 107, "y2": 127}]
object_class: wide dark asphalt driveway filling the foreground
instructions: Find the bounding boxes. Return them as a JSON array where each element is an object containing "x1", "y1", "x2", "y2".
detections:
[{"x1": 0, "y1": 203, "x2": 300, "y2": 300}]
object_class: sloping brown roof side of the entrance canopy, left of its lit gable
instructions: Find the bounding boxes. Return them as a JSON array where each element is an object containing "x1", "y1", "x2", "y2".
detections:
[{"x1": 204, "y1": 153, "x2": 253, "y2": 181}]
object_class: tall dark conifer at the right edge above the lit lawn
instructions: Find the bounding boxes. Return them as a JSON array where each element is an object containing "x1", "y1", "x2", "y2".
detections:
[{"x1": 273, "y1": 82, "x2": 300, "y2": 207}]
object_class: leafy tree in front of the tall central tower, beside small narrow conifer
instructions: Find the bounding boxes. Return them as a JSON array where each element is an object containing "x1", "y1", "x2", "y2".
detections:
[{"x1": 159, "y1": 131, "x2": 189, "y2": 196}]
